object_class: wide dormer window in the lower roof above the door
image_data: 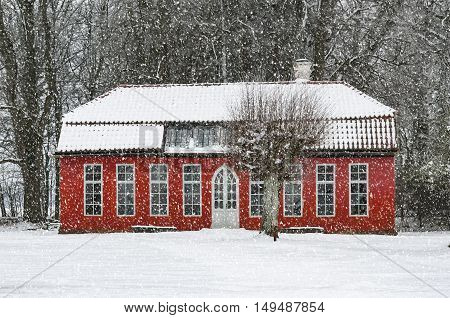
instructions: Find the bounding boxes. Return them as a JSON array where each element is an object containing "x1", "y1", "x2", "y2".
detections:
[{"x1": 166, "y1": 126, "x2": 229, "y2": 148}]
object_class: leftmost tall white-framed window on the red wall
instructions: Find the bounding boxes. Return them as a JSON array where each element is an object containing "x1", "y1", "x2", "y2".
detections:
[{"x1": 84, "y1": 165, "x2": 102, "y2": 215}]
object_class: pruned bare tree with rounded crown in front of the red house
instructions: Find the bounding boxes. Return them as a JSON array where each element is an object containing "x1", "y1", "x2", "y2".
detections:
[{"x1": 230, "y1": 84, "x2": 327, "y2": 240}]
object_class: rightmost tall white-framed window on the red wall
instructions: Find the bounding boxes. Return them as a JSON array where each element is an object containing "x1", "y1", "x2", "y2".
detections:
[{"x1": 350, "y1": 164, "x2": 369, "y2": 216}]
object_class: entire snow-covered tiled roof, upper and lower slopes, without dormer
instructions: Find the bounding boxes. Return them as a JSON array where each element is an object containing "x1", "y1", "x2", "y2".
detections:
[{"x1": 56, "y1": 82, "x2": 397, "y2": 154}]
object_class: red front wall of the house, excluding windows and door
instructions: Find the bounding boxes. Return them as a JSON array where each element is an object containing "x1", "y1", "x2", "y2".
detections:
[{"x1": 59, "y1": 155, "x2": 395, "y2": 234}]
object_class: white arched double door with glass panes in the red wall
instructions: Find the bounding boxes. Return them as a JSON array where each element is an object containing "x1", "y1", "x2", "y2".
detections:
[{"x1": 212, "y1": 166, "x2": 239, "y2": 229}]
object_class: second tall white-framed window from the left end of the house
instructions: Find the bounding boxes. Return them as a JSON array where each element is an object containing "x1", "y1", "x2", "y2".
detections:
[{"x1": 117, "y1": 164, "x2": 134, "y2": 215}]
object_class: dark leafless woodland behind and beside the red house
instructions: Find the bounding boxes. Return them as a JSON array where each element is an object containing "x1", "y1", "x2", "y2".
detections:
[{"x1": 0, "y1": 0, "x2": 450, "y2": 229}]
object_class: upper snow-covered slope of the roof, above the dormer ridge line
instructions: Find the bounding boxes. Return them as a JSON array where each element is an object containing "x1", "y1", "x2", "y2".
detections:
[{"x1": 64, "y1": 82, "x2": 395, "y2": 123}]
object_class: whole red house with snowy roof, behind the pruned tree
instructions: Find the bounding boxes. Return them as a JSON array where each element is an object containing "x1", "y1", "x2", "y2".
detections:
[{"x1": 56, "y1": 81, "x2": 397, "y2": 233}]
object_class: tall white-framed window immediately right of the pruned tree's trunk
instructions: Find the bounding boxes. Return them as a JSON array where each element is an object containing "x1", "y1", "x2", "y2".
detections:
[{"x1": 284, "y1": 164, "x2": 302, "y2": 216}]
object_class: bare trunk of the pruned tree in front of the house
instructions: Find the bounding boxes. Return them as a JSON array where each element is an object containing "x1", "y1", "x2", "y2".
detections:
[{"x1": 261, "y1": 175, "x2": 281, "y2": 240}]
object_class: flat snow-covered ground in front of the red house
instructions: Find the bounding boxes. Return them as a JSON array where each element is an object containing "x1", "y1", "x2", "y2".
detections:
[{"x1": 0, "y1": 227, "x2": 450, "y2": 298}]
